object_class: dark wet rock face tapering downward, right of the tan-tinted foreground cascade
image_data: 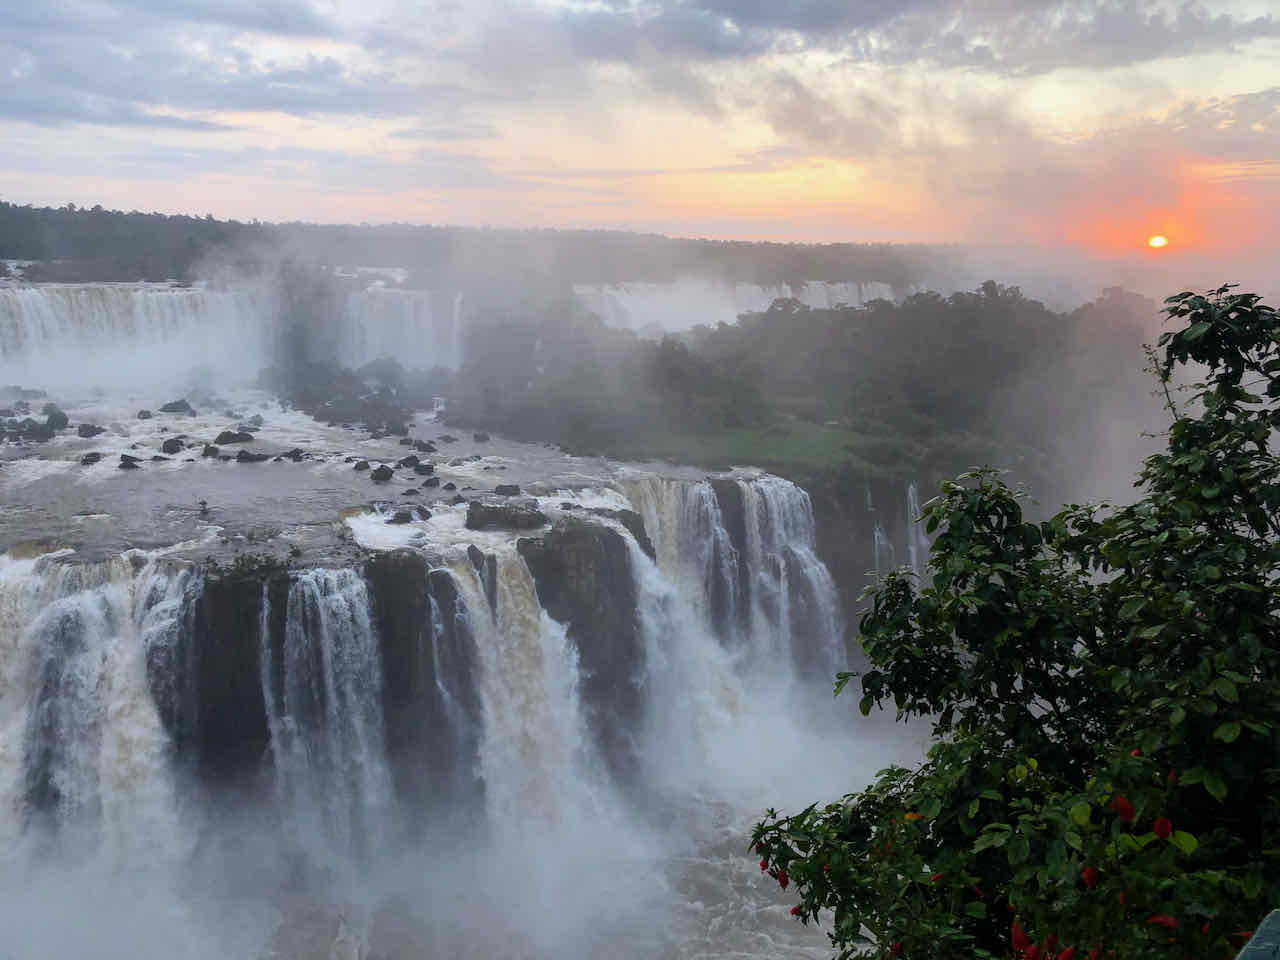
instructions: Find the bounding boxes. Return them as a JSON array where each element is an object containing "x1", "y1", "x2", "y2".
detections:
[{"x1": 517, "y1": 518, "x2": 645, "y2": 785}]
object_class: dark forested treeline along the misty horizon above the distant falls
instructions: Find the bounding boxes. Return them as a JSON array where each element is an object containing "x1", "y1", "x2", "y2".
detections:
[{"x1": 0, "y1": 201, "x2": 948, "y2": 292}]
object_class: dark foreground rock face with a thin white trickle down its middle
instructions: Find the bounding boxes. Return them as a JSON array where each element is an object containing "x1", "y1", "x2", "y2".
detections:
[{"x1": 365, "y1": 550, "x2": 483, "y2": 826}]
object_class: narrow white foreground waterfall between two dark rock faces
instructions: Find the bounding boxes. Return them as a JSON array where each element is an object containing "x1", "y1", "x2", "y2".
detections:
[{"x1": 260, "y1": 570, "x2": 393, "y2": 851}]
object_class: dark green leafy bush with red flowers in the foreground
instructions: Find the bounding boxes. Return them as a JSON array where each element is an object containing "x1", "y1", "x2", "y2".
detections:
[{"x1": 753, "y1": 287, "x2": 1280, "y2": 960}]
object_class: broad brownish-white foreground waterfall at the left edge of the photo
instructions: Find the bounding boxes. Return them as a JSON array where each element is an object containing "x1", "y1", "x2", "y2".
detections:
[{"x1": 0, "y1": 554, "x2": 191, "y2": 860}]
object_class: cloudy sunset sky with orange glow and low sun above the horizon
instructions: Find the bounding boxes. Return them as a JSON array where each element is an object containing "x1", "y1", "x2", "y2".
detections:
[{"x1": 0, "y1": 0, "x2": 1280, "y2": 253}]
